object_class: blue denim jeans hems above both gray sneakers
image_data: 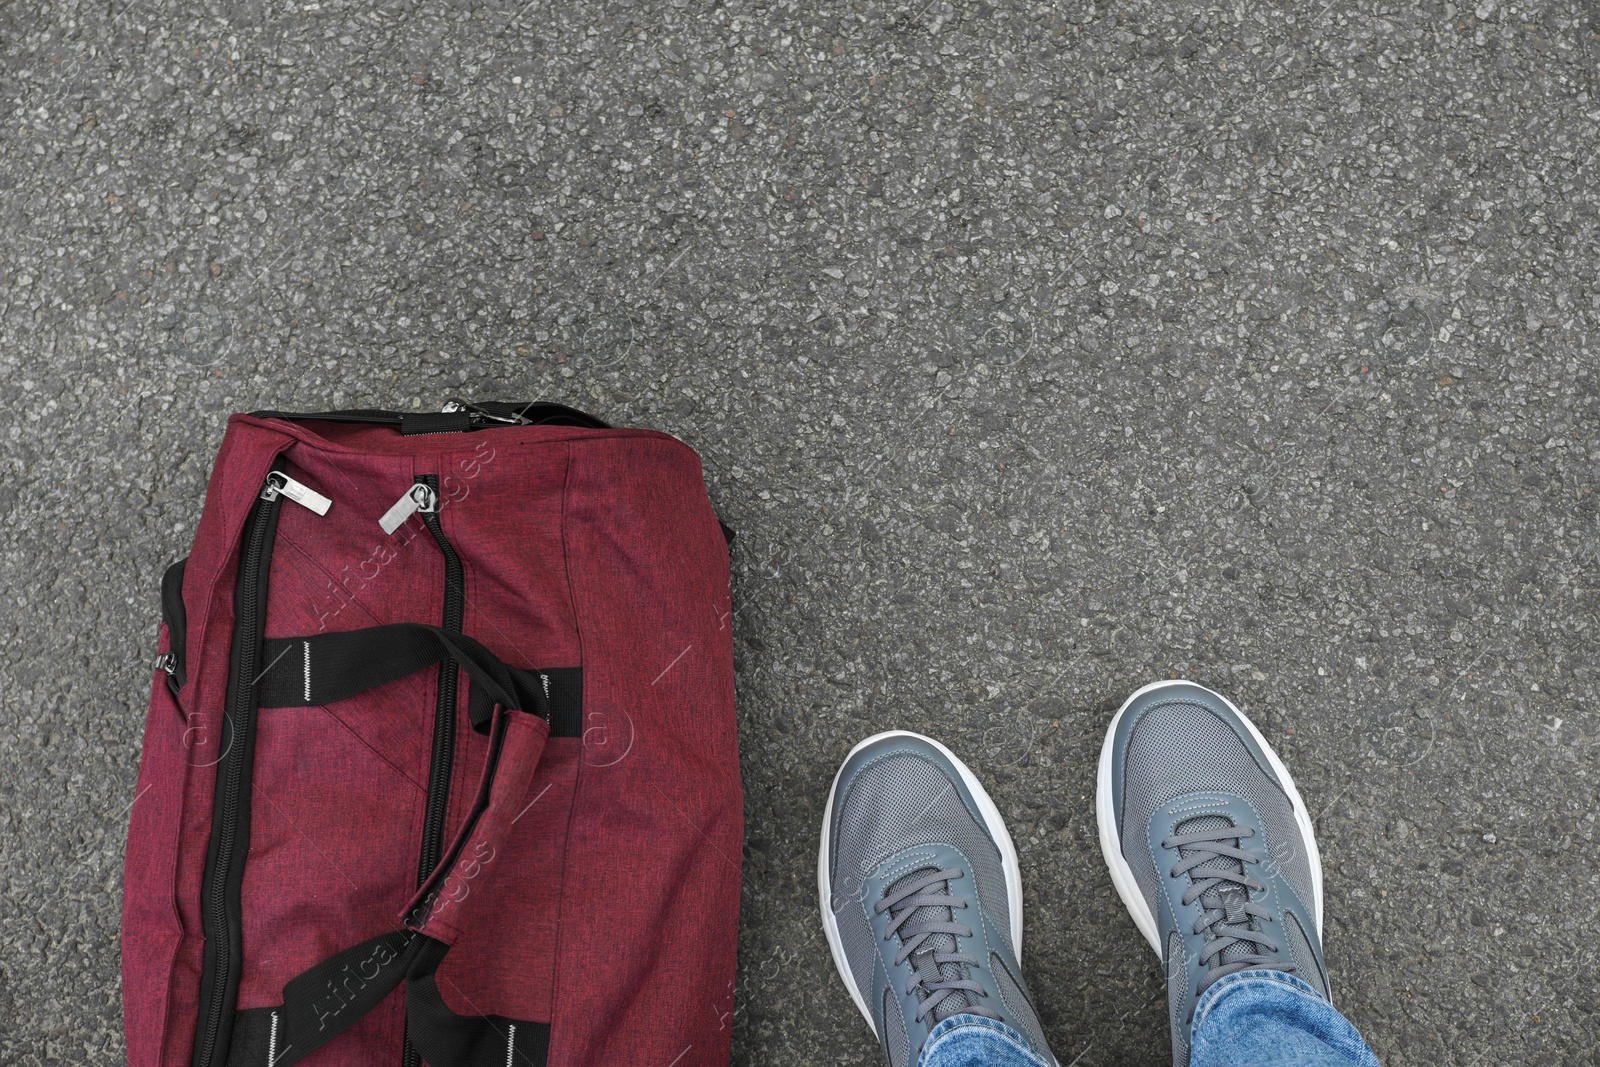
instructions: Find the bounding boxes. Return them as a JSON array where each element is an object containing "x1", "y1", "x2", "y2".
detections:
[{"x1": 917, "y1": 971, "x2": 1378, "y2": 1067}]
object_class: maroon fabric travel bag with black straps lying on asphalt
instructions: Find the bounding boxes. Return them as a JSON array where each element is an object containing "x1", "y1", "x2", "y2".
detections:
[{"x1": 122, "y1": 403, "x2": 744, "y2": 1067}]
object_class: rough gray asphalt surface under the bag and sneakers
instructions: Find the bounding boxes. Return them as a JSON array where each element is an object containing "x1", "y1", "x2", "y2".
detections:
[{"x1": 0, "y1": 0, "x2": 1600, "y2": 1067}]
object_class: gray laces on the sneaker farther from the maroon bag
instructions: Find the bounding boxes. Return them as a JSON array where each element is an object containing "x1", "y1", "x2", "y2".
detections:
[{"x1": 1162, "y1": 816, "x2": 1296, "y2": 993}]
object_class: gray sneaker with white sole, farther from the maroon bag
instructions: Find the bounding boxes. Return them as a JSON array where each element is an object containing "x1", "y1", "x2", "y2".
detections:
[{"x1": 1094, "y1": 681, "x2": 1328, "y2": 1067}]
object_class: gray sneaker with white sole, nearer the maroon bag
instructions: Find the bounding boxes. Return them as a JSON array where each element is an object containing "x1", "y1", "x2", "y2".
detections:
[{"x1": 818, "y1": 731, "x2": 1054, "y2": 1067}]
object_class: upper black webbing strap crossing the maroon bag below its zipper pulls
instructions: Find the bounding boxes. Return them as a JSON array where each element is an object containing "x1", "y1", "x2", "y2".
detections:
[{"x1": 254, "y1": 622, "x2": 560, "y2": 733}]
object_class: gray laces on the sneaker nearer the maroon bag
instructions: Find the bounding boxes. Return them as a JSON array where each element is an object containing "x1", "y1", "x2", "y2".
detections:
[{"x1": 874, "y1": 867, "x2": 1000, "y2": 1022}]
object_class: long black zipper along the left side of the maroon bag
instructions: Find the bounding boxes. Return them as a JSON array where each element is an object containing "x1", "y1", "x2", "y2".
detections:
[{"x1": 194, "y1": 464, "x2": 285, "y2": 1067}]
